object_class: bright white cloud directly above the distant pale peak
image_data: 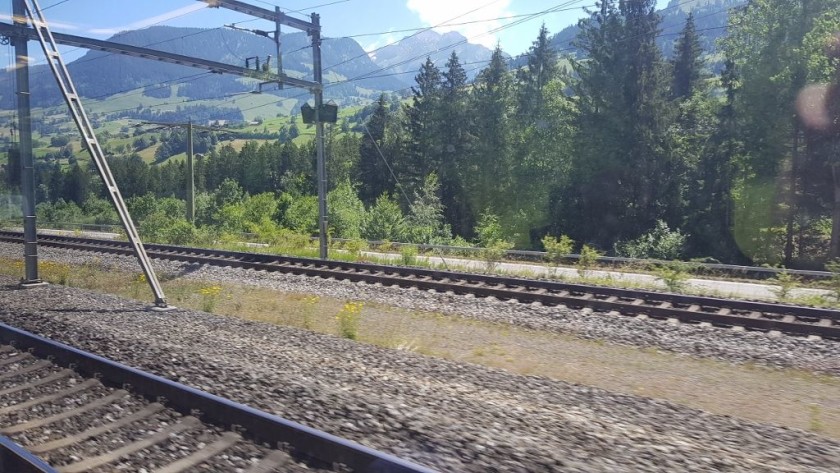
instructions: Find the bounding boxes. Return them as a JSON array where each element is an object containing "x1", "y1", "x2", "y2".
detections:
[{"x1": 406, "y1": 0, "x2": 513, "y2": 48}]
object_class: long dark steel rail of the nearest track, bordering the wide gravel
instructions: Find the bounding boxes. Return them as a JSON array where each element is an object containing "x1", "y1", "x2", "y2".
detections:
[{"x1": 0, "y1": 323, "x2": 434, "y2": 473}]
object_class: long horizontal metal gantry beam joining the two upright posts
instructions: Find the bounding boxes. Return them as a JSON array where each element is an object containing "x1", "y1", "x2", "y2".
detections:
[{"x1": 0, "y1": 23, "x2": 321, "y2": 90}]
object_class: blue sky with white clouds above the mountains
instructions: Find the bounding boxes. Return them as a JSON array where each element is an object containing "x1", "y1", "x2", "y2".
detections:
[{"x1": 0, "y1": 0, "x2": 612, "y2": 60}]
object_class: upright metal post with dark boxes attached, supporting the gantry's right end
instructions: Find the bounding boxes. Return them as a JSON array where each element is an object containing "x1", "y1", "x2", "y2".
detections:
[{"x1": 309, "y1": 13, "x2": 327, "y2": 259}]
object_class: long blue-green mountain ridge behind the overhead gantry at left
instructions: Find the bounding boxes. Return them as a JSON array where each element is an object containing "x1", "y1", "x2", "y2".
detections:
[{"x1": 0, "y1": 26, "x2": 405, "y2": 109}]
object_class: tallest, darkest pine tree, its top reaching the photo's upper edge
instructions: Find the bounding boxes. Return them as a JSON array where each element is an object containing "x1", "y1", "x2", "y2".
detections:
[{"x1": 555, "y1": 0, "x2": 675, "y2": 247}]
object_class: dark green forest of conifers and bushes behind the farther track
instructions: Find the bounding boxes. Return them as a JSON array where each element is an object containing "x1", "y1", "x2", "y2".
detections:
[{"x1": 6, "y1": 0, "x2": 840, "y2": 268}]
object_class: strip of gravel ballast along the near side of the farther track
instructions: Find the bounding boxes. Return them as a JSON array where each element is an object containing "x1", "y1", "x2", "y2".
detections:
[{"x1": 0, "y1": 242, "x2": 840, "y2": 376}]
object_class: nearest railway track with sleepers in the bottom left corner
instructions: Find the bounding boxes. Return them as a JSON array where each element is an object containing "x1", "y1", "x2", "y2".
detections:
[{"x1": 0, "y1": 324, "x2": 432, "y2": 473}]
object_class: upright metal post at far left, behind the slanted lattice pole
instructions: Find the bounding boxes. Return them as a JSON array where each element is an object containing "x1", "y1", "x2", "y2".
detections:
[{"x1": 12, "y1": 0, "x2": 42, "y2": 287}]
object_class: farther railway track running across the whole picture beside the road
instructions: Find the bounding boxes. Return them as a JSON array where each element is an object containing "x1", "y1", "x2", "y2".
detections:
[{"x1": 0, "y1": 231, "x2": 840, "y2": 340}]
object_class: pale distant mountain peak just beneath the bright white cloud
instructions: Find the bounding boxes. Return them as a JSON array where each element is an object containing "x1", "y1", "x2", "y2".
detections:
[{"x1": 371, "y1": 30, "x2": 493, "y2": 81}]
